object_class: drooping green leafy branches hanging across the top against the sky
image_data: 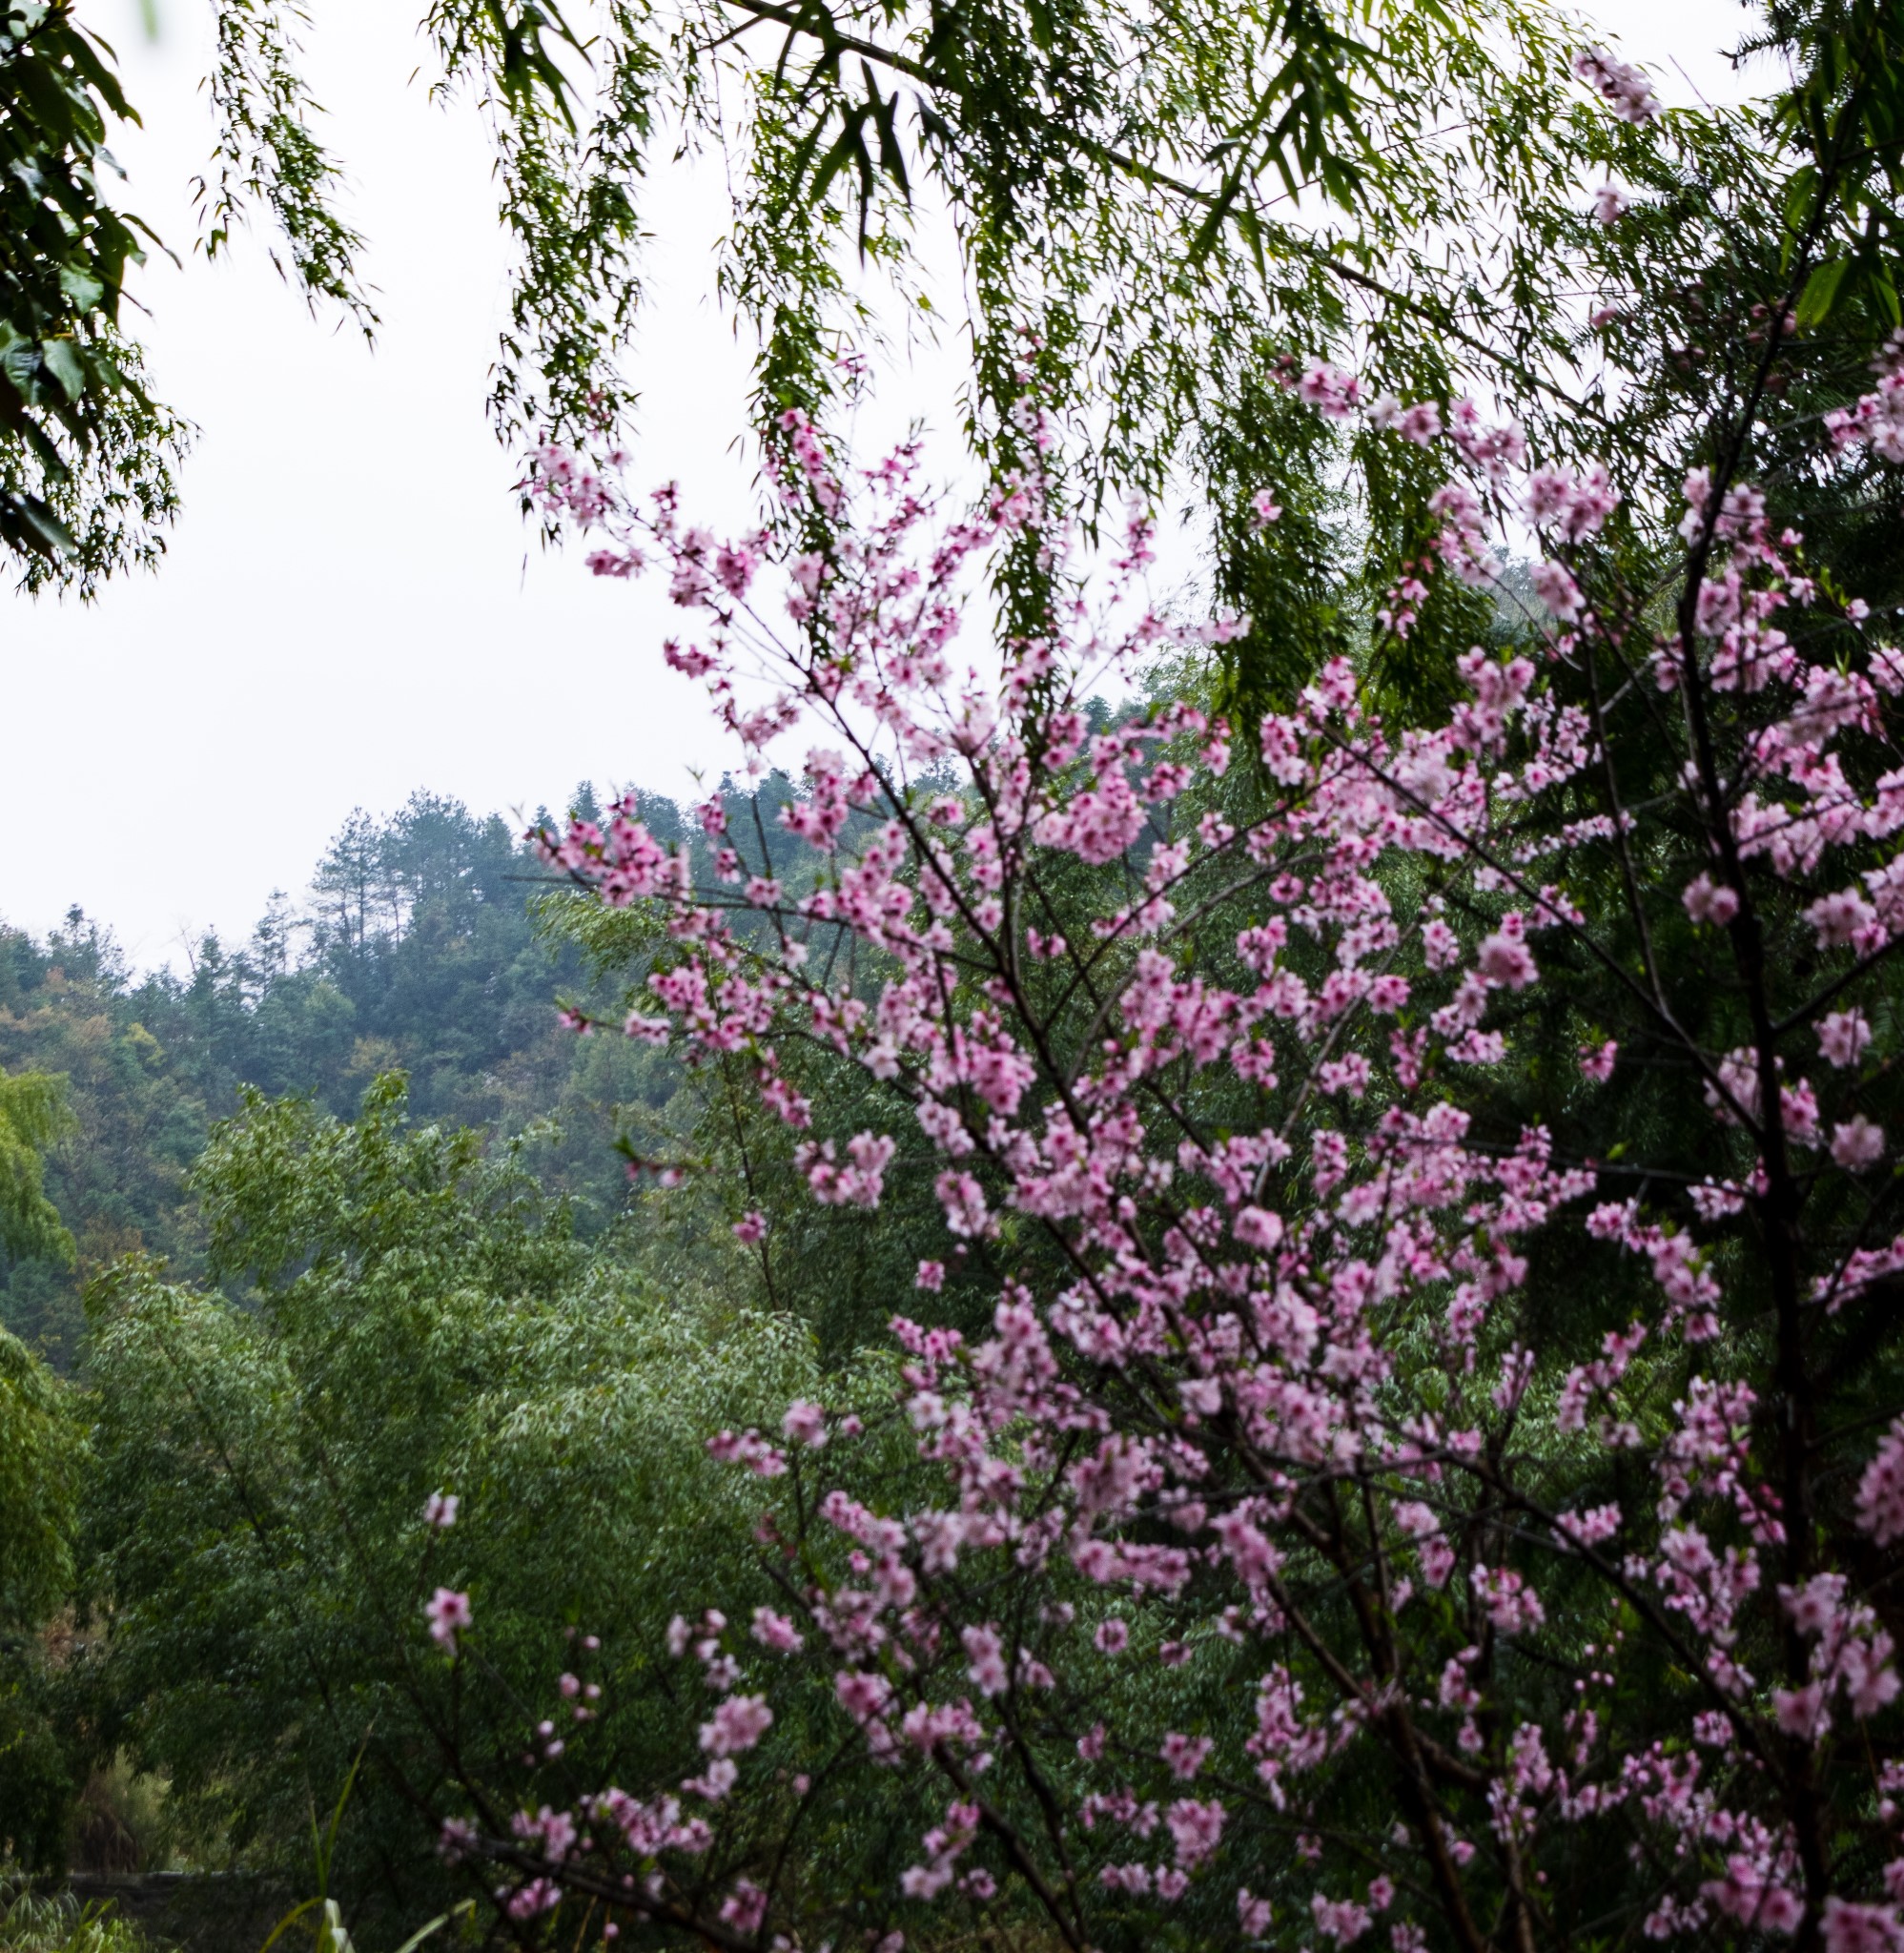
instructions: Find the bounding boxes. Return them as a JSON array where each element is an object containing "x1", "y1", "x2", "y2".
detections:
[{"x1": 0, "y1": 0, "x2": 1898, "y2": 656}]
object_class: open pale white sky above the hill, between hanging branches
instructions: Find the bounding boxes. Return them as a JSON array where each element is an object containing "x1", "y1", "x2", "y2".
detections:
[{"x1": 0, "y1": 0, "x2": 1744, "y2": 965}]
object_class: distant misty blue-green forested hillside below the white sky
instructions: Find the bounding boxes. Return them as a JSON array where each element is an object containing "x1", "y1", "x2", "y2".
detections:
[{"x1": 0, "y1": 785, "x2": 680, "y2": 1367}]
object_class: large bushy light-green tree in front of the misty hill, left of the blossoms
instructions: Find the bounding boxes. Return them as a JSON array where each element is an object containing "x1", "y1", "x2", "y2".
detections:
[{"x1": 86, "y1": 1080, "x2": 810, "y2": 1923}]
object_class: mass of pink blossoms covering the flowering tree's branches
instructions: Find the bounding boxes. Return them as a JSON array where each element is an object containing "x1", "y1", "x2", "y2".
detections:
[{"x1": 507, "y1": 392, "x2": 1904, "y2": 1953}]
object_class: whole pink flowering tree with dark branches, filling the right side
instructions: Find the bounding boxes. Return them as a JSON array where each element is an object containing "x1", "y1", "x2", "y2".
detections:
[{"x1": 410, "y1": 34, "x2": 1904, "y2": 1953}]
